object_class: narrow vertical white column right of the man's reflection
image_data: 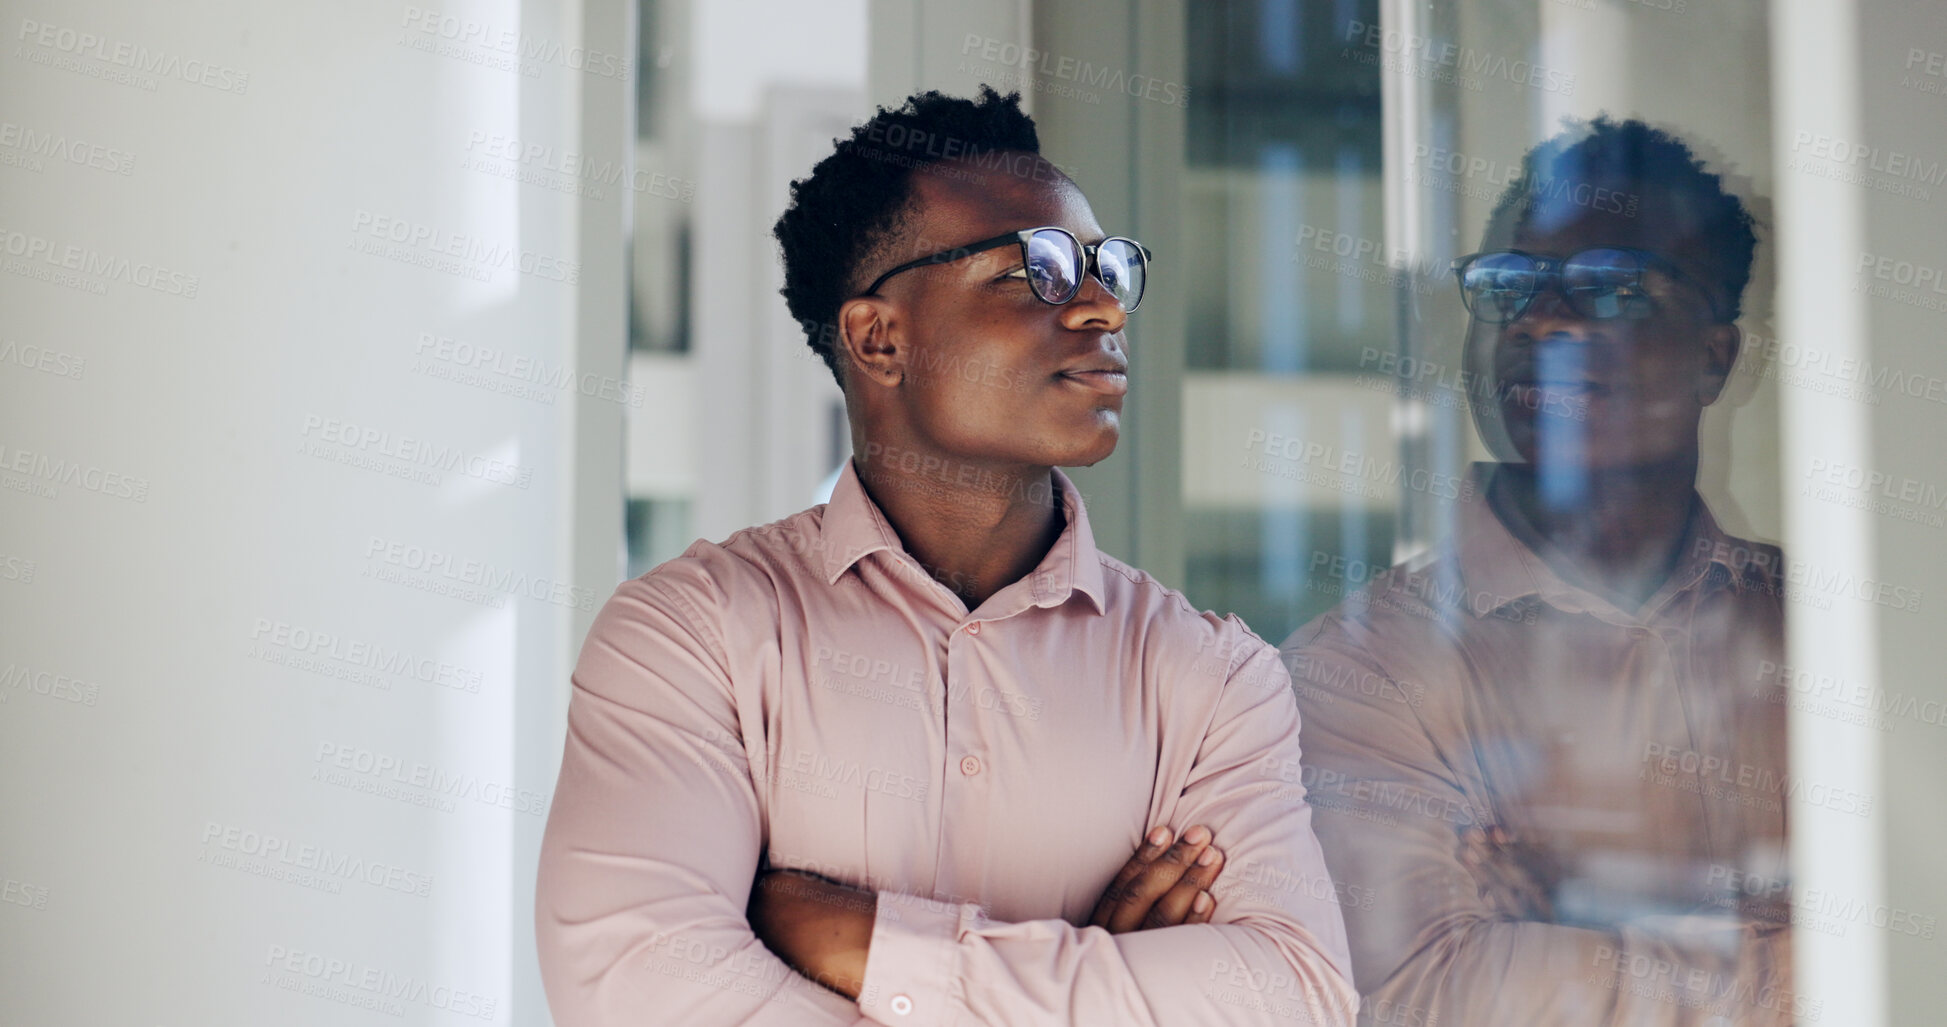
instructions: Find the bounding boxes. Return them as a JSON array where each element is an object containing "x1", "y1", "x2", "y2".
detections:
[{"x1": 1772, "y1": 0, "x2": 1891, "y2": 1027}]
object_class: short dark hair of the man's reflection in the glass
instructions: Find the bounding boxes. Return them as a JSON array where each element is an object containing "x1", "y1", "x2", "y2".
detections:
[{"x1": 1488, "y1": 115, "x2": 1758, "y2": 322}]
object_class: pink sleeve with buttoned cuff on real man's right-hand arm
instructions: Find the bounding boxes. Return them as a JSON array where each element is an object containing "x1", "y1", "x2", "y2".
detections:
[{"x1": 844, "y1": 643, "x2": 1359, "y2": 1027}]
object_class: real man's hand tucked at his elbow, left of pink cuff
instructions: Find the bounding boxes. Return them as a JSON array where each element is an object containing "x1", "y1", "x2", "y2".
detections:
[{"x1": 746, "y1": 871, "x2": 878, "y2": 1000}]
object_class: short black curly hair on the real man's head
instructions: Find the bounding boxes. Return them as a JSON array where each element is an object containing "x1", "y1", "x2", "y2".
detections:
[{"x1": 771, "y1": 86, "x2": 1042, "y2": 386}]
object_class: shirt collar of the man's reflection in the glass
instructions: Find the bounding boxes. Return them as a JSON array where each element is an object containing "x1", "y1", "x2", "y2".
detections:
[{"x1": 1454, "y1": 462, "x2": 1772, "y2": 620}]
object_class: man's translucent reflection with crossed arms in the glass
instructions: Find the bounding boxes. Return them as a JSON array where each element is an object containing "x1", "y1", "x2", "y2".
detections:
[{"x1": 1285, "y1": 119, "x2": 1807, "y2": 1025}]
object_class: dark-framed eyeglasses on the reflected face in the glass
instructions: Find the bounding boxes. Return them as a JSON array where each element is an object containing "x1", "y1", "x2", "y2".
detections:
[{"x1": 1452, "y1": 246, "x2": 1725, "y2": 325}]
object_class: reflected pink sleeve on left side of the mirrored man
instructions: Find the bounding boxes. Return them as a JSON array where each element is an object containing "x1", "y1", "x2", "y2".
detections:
[{"x1": 1285, "y1": 629, "x2": 1809, "y2": 1027}]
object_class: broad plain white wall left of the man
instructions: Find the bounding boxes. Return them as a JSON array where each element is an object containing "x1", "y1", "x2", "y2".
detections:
[{"x1": 0, "y1": 0, "x2": 635, "y2": 1027}]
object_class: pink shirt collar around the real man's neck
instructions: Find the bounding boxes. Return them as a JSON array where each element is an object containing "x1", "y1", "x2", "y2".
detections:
[{"x1": 816, "y1": 460, "x2": 1108, "y2": 616}]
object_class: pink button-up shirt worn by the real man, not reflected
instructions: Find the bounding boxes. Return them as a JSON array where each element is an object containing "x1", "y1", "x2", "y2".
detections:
[{"x1": 535, "y1": 464, "x2": 1357, "y2": 1027}]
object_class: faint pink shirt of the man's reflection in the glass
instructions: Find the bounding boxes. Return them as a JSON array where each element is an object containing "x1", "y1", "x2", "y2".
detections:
[{"x1": 1285, "y1": 466, "x2": 1791, "y2": 1027}]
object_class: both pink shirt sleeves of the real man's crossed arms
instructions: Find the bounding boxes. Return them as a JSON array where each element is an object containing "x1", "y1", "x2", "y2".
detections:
[{"x1": 535, "y1": 579, "x2": 1357, "y2": 1027}]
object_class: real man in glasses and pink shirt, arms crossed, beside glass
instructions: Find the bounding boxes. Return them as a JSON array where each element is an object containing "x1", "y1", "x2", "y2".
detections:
[{"x1": 537, "y1": 90, "x2": 1355, "y2": 1027}]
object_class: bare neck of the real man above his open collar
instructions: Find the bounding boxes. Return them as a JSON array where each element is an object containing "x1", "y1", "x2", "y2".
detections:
[{"x1": 853, "y1": 446, "x2": 1067, "y2": 610}]
